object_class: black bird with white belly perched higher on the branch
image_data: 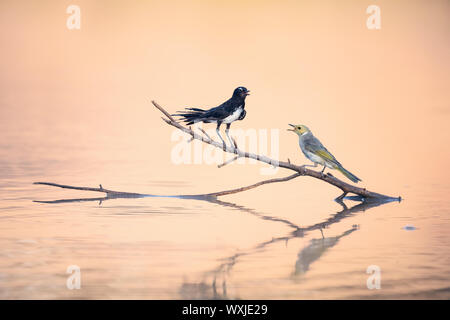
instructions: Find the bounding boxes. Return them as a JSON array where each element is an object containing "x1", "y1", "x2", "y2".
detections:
[{"x1": 174, "y1": 87, "x2": 250, "y2": 145}]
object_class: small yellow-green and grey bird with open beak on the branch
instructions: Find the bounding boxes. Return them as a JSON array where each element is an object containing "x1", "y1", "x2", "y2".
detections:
[{"x1": 288, "y1": 124, "x2": 361, "y2": 183}]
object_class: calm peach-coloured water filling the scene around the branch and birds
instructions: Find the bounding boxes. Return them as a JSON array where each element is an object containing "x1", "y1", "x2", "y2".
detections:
[{"x1": 0, "y1": 1, "x2": 450, "y2": 299}]
